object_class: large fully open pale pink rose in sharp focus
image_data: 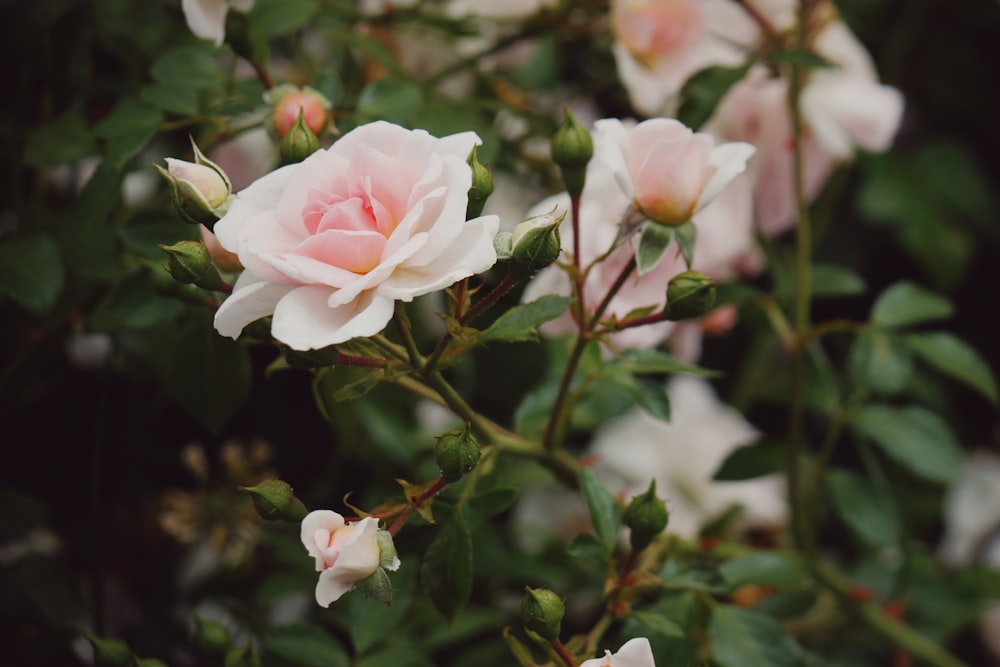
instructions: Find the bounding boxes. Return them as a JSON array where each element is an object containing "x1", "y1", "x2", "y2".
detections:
[{"x1": 215, "y1": 122, "x2": 499, "y2": 350}]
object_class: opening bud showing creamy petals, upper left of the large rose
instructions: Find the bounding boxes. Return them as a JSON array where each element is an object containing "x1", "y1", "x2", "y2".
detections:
[{"x1": 154, "y1": 139, "x2": 233, "y2": 229}]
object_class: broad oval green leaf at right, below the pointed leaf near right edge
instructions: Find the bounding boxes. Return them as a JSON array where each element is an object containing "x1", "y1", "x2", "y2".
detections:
[{"x1": 848, "y1": 405, "x2": 962, "y2": 483}]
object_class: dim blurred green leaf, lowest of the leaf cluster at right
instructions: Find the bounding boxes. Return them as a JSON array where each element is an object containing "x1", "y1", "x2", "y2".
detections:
[{"x1": 826, "y1": 470, "x2": 901, "y2": 546}]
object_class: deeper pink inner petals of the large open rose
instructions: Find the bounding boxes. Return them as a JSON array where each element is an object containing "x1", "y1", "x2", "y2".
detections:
[{"x1": 298, "y1": 183, "x2": 397, "y2": 274}]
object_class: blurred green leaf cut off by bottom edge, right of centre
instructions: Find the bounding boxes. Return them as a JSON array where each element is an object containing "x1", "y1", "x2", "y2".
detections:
[{"x1": 708, "y1": 605, "x2": 802, "y2": 667}]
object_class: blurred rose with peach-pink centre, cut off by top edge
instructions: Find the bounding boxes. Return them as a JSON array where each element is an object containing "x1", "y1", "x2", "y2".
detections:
[{"x1": 611, "y1": 0, "x2": 757, "y2": 116}]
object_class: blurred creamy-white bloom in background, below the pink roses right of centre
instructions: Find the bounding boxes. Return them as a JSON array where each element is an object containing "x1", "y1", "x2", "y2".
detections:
[{"x1": 590, "y1": 376, "x2": 788, "y2": 537}]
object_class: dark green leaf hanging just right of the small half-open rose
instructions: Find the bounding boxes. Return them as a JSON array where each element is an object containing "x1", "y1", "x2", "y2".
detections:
[{"x1": 420, "y1": 512, "x2": 472, "y2": 623}]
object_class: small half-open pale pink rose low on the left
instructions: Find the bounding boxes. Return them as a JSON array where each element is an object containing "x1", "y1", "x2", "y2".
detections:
[{"x1": 301, "y1": 510, "x2": 399, "y2": 607}]
